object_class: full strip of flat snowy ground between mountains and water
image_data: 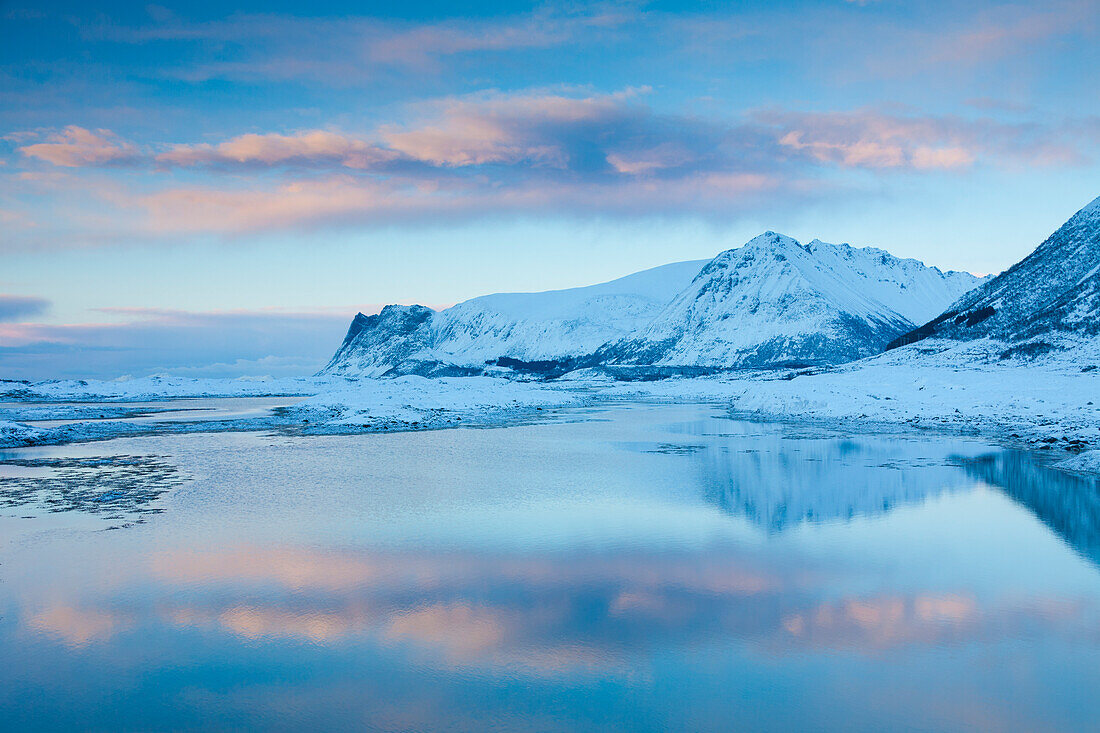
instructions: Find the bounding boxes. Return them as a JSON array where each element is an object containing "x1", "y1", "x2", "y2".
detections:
[{"x1": 0, "y1": 344, "x2": 1100, "y2": 471}]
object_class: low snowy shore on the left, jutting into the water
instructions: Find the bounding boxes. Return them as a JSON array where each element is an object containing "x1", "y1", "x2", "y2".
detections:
[{"x1": 0, "y1": 376, "x2": 593, "y2": 449}]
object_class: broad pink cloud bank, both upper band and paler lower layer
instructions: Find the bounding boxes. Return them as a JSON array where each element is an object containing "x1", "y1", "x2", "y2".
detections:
[{"x1": 6, "y1": 89, "x2": 1100, "y2": 237}]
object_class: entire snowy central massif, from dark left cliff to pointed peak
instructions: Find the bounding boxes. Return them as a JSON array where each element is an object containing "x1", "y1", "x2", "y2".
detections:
[{"x1": 323, "y1": 232, "x2": 979, "y2": 376}]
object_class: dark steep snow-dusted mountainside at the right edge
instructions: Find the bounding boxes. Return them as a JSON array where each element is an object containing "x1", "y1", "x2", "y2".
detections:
[{"x1": 890, "y1": 192, "x2": 1100, "y2": 357}]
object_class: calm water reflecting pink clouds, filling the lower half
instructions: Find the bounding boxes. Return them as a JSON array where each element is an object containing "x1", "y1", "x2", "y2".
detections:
[{"x1": 0, "y1": 406, "x2": 1100, "y2": 731}]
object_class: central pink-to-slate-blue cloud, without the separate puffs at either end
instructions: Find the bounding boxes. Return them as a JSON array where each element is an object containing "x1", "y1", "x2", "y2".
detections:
[{"x1": 156, "y1": 89, "x2": 704, "y2": 173}]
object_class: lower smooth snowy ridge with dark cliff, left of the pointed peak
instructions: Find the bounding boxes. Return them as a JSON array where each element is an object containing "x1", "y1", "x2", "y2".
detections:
[{"x1": 322, "y1": 260, "x2": 706, "y2": 376}]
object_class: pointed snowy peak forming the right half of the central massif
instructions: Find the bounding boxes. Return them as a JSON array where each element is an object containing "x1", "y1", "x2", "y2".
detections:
[{"x1": 596, "y1": 232, "x2": 979, "y2": 368}]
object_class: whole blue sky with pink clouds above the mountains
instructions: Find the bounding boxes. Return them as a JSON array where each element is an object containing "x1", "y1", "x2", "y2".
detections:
[{"x1": 0, "y1": 0, "x2": 1100, "y2": 380}]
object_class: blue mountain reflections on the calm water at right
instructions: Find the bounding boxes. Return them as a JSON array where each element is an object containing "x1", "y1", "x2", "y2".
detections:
[{"x1": 657, "y1": 413, "x2": 1100, "y2": 565}]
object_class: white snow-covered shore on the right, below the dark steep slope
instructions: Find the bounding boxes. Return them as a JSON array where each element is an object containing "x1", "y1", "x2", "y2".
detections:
[{"x1": 607, "y1": 365, "x2": 1100, "y2": 472}]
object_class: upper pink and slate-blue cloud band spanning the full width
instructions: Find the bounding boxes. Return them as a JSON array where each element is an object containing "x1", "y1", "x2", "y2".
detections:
[{"x1": 23, "y1": 88, "x2": 1098, "y2": 178}]
